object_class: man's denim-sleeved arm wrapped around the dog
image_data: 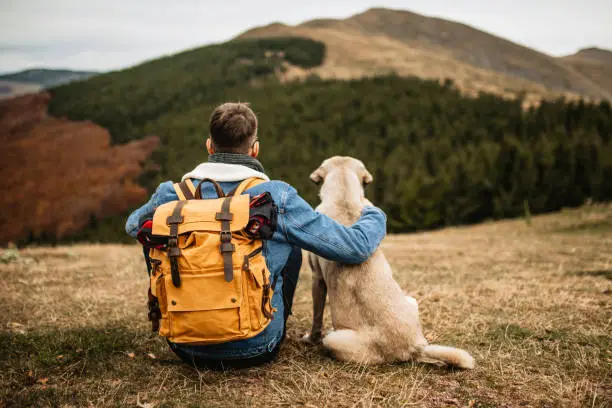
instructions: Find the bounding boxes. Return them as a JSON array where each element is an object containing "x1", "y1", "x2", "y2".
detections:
[{"x1": 279, "y1": 186, "x2": 387, "y2": 264}]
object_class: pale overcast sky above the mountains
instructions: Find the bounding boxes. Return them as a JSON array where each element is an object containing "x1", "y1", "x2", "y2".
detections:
[{"x1": 0, "y1": 0, "x2": 612, "y2": 73}]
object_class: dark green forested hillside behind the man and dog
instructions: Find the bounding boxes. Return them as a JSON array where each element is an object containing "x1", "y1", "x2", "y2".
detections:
[{"x1": 44, "y1": 38, "x2": 612, "y2": 240}]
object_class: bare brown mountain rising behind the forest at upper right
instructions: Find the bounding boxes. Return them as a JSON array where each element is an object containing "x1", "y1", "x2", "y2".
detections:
[{"x1": 238, "y1": 8, "x2": 612, "y2": 100}]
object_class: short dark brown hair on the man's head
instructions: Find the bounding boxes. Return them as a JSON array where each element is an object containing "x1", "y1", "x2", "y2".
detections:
[{"x1": 210, "y1": 102, "x2": 257, "y2": 153}]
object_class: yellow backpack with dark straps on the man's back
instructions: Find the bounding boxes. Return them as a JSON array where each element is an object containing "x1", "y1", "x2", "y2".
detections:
[{"x1": 149, "y1": 178, "x2": 276, "y2": 345}]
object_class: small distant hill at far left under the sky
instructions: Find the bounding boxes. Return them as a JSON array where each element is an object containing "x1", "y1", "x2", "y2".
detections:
[{"x1": 0, "y1": 68, "x2": 98, "y2": 99}]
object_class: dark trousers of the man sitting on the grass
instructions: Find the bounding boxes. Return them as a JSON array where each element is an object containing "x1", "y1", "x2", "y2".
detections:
[{"x1": 168, "y1": 247, "x2": 302, "y2": 371}]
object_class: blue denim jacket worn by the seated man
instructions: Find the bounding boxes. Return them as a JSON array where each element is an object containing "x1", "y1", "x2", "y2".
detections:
[{"x1": 125, "y1": 175, "x2": 386, "y2": 359}]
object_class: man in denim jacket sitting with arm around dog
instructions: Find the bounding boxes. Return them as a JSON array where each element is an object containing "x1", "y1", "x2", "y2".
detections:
[{"x1": 126, "y1": 103, "x2": 386, "y2": 369}]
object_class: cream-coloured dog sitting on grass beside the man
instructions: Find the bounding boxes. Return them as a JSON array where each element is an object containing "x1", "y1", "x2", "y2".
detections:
[{"x1": 303, "y1": 156, "x2": 474, "y2": 368}]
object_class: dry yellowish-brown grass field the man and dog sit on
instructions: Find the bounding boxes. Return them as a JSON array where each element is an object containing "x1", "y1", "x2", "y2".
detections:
[{"x1": 0, "y1": 205, "x2": 612, "y2": 408}]
